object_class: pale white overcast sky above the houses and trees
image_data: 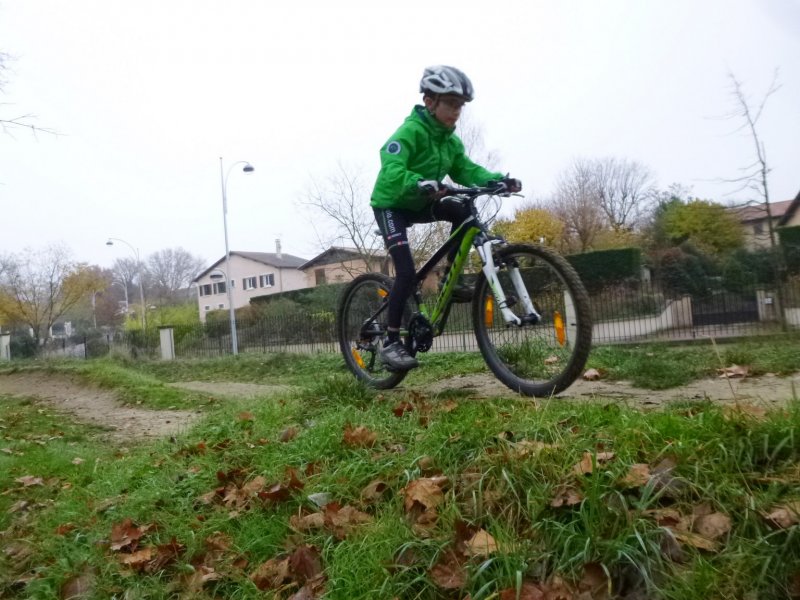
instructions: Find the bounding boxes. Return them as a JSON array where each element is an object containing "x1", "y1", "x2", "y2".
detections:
[{"x1": 0, "y1": 0, "x2": 800, "y2": 266}]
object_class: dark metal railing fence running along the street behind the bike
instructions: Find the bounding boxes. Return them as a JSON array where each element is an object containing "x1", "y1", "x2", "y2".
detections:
[{"x1": 7, "y1": 279, "x2": 800, "y2": 358}]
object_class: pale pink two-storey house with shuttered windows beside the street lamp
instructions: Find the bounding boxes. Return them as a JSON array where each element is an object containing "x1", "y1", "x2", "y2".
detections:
[{"x1": 192, "y1": 250, "x2": 307, "y2": 322}]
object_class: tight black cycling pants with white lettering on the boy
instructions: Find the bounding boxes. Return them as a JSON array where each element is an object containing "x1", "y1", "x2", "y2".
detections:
[{"x1": 373, "y1": 197, "x2": 470, "y2": 329}]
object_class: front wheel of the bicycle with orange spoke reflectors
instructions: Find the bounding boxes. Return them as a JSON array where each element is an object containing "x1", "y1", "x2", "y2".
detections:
[{"x1": 472, "y1": 244, "x2": 592, "y2": 397}]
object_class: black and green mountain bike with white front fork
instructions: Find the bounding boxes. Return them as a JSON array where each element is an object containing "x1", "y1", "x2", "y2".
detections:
[{"x1": 336, "y1": 186, "x2": 592, "y2": 397}]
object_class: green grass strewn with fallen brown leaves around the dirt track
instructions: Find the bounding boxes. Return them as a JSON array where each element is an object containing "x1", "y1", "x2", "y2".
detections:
[{"x1": 0, "y1": 345, "x2": 800, "y2": 600}]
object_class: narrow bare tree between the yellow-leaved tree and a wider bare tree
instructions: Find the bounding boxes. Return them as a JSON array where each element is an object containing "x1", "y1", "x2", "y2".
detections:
[{"x1": 546, "y1": 158, "x2": 606, "y2": 252}]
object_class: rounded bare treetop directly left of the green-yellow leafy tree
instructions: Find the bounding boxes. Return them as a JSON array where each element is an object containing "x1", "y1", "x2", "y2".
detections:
[{"x1": 592, "y1": 157, "x2": 655, "y2": 231}]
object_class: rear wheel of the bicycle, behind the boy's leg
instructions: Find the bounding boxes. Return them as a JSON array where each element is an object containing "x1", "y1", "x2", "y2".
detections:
[{"x1": 336, "y1": 273, "x2": 408, "y2": 389}]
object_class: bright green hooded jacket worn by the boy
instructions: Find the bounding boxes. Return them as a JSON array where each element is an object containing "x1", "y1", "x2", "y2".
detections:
[{"x1": 370, "y1": 106, "x2": 504, "y2": 211}]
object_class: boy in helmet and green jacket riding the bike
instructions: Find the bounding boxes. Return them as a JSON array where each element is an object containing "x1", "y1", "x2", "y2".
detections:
[{"x1": 370, "y1": 65, "x2": 522, "y2": 371}]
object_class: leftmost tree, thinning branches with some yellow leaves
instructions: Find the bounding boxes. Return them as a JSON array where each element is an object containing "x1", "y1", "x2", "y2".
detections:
[{"x1": 0, "y1": 245, "x2": 104, "y2": 347}]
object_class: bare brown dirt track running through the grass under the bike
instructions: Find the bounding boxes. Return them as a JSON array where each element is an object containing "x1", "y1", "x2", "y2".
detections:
[{"x1": 0, "y1": 373, "x2": 800, "y2": 442}]
